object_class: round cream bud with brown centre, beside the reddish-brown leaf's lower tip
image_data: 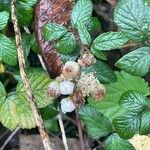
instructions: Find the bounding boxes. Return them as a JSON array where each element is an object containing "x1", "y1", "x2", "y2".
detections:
[{"x1": 63, "y1": 61, "x2": 80, "y2": 78}]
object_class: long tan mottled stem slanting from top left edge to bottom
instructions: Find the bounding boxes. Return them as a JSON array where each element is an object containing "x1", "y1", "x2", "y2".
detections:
[{"x1": 11, "y1": 0, "x2": 52, "y2": 150}]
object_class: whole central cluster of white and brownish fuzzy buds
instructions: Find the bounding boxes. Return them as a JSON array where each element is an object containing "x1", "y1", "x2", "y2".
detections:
[{"x1": 47, "y1": 57, "x2": 105, "y2": 113}]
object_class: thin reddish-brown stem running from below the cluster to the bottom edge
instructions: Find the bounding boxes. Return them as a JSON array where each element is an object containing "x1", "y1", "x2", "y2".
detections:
[{"x1": 76, "y1": 110, "x2": 85, "y2": 150}]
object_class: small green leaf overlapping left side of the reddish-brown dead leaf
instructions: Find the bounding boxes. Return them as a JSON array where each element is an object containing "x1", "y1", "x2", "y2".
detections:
[{"x1": 43, "y1": 23, "x2": 67, "y2": 41}]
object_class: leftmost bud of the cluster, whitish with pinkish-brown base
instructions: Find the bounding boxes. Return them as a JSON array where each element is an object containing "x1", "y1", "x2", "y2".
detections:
[{"x1": 47, "y1": 81, "x2": 61, "y2": 97}]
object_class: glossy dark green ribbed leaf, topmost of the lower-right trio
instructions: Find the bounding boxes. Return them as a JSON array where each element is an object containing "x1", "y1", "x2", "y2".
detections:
[{"x1": 119, "y1": 91, "x2": 146, "y2": 112}]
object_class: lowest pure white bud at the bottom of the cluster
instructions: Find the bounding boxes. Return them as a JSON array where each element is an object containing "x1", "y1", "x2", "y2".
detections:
[{"x1": 61, "y1": 98, "x2": 76, "y2": 113}]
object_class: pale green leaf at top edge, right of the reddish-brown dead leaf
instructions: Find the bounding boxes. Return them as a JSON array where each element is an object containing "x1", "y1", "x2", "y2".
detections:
[{"x1": 71, "y1": 0, "x2": 93, "y2": 27}]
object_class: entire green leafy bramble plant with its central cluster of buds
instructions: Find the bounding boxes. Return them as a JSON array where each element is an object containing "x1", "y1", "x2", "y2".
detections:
[{"x1": 0, "y1": 0, "x2": 150, "y2": 150}]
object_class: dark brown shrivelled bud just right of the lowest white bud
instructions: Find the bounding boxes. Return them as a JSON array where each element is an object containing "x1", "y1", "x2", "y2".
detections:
[{"x1": 72, "y1": 91, "x2": 85, "y2": 107}]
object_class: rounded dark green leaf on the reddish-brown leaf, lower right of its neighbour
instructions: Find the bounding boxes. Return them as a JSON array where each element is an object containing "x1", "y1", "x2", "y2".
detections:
[{"x1": 56, "y1": 32, "x2": 77, "y2": 55}]
